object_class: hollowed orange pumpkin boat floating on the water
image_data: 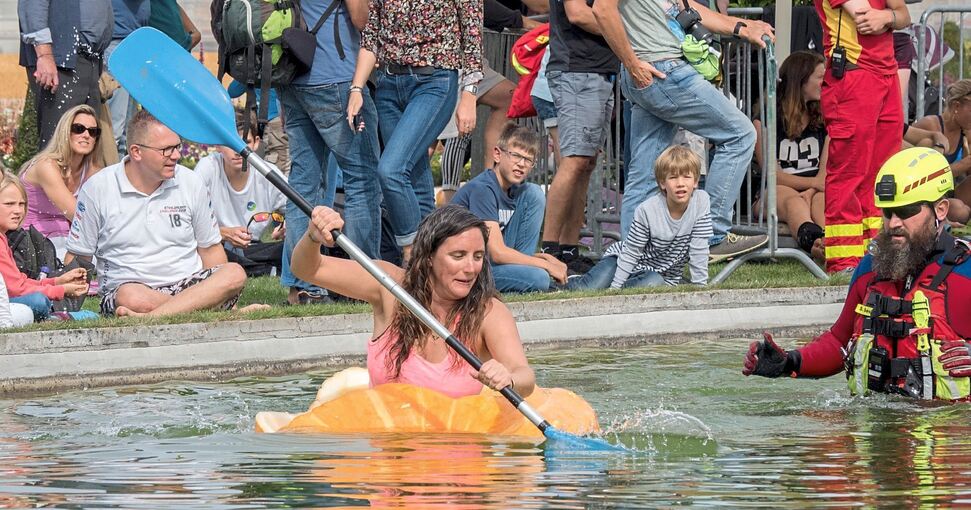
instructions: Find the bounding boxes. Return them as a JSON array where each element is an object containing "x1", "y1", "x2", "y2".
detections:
[{"x1": 256, "y1": 368, "x2": 600, "y2": 437}]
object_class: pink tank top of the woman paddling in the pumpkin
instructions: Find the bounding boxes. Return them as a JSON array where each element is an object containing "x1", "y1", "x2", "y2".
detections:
[{"x1": 368, "y1": 327, "x2": 482, "y2": 398}]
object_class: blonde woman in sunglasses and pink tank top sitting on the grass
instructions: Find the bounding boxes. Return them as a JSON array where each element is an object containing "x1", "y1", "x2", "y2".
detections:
[{"x1": 19, "y1": 105, "x2": 111, "y2": 259}]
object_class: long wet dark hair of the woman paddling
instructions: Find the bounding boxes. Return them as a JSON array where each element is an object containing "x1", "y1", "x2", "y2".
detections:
[{"x1": 387, "y1": 205, "x2": 498, "y2": 378}]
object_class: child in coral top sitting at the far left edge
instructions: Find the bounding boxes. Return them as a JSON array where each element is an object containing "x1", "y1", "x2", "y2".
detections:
[{"x1": 0, "y1": 172, "x2": 88, "y2": 320}]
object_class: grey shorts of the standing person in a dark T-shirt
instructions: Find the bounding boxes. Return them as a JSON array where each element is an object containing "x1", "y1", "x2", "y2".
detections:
[{"x1": 546, "y1": 71, "x2": 614, "y2": 157}]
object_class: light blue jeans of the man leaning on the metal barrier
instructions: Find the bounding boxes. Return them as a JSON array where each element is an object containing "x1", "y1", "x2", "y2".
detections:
[{"x1": 620, "y1": 59, "x2": 755, "y2": 244}]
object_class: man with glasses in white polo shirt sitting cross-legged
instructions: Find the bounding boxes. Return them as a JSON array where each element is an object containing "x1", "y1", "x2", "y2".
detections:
[{"x1": 67, "y1": 110, "x2": 246, "y2": 316}]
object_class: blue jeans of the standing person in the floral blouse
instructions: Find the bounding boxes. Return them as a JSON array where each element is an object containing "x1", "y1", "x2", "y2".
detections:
[{"x1": 376, "y1": 69, "x2": 458, "y2": 246}]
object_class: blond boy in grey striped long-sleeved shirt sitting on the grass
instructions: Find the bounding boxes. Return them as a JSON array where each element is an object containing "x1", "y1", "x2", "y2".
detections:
[{"x1": 567, "y1": 145, "x2": 712, "y2": 290}]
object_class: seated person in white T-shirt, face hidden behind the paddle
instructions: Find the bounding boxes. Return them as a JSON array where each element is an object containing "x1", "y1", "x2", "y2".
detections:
[{"x1": 195, "y1": 110, "x2": 287, "y2": 276}]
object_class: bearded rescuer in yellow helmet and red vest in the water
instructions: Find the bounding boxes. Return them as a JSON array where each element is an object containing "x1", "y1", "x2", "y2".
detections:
[{"x1": 742, "y1": 147, "x2": 971, "y2": 400}]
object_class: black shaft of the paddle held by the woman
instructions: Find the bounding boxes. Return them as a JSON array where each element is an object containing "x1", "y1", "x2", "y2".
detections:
[{"x1": 240, "y1": 147, "x2": 550, "y2": 432}]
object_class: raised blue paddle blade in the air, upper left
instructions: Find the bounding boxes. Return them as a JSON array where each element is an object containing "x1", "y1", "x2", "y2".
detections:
[{"x1": 108, "y1": 27, "x2": 246, "y2": 152}]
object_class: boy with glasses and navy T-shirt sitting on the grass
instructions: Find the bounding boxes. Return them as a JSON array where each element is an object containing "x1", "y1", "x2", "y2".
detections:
[{"x1": 452, "y1": 123, "x2": 566, "y2": 292}]
